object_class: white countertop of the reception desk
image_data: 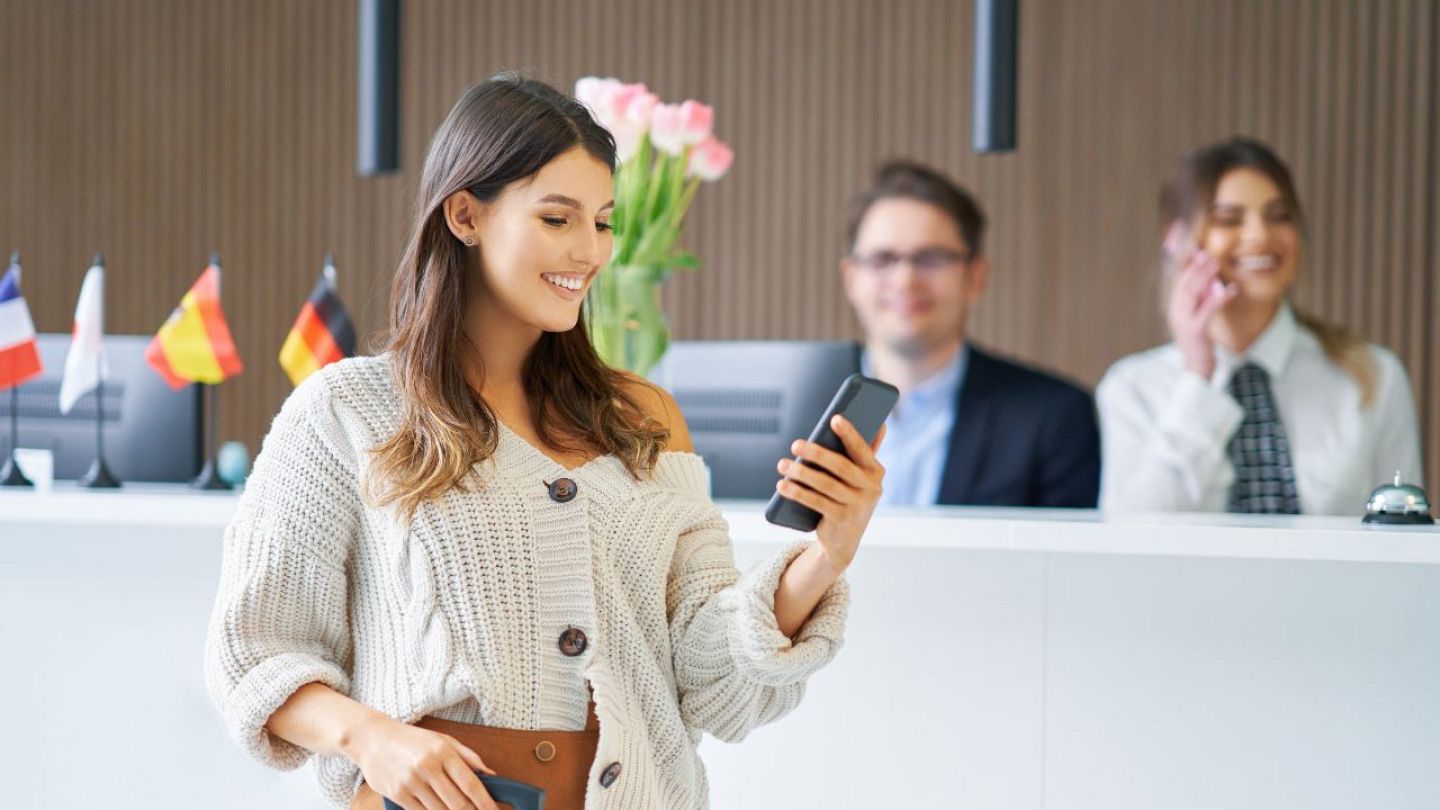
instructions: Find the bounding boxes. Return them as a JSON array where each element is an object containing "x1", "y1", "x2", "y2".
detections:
[{"x1": 0, "y1": 484, "x2": 1440, "y2": 565}]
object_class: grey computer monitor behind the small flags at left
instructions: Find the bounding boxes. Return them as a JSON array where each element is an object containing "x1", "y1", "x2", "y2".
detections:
[{"x1": 0, "y1": 334, "x2": 203, "y2": 481}]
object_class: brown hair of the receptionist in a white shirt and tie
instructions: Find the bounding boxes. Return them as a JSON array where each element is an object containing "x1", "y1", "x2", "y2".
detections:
[{"x1": 1161, "y1": 137, "x2": 1375, "y2": 405}]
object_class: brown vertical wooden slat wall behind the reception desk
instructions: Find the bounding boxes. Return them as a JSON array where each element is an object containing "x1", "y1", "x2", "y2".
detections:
[{"x1": 0, "y1": 0, "x2": 1440, "y2": 483}]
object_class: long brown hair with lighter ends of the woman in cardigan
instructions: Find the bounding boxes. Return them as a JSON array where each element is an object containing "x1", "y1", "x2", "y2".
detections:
[{"x1": 366, "y1": 74, "x2": 668, "y2": 519}]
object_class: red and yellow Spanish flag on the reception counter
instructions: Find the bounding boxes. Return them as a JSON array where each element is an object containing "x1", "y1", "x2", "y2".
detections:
[{"x1": 145, "y1": 257, "x2": 243, "y2": 389}]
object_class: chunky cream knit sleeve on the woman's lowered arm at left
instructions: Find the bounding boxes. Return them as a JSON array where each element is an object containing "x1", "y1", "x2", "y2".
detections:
[{"x1": 204, "y1": 372, "x2": 359, "y2": 770}]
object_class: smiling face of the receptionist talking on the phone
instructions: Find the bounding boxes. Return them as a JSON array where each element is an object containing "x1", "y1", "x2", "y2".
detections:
[{"x1": 1200, "y1": 169, "x2": 1300, "y2": 304}]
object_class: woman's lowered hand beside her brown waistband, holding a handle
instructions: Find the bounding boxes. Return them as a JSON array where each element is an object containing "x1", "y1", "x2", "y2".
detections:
[{"x1": 346, "y1": 716, "x2": 498, "y2": 810}]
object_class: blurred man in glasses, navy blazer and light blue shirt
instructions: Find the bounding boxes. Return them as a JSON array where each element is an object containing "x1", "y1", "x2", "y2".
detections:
[{"x1": 840, "y1": 161, "x2": 1100, "y2": 509}]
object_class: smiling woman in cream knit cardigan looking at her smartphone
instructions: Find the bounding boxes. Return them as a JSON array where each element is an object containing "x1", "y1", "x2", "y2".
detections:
[{"x1": 198, "y1": 76, "x2": 883, "y2": 810}]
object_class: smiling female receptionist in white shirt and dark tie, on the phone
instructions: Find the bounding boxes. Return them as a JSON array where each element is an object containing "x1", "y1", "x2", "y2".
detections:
[{"x1": 1096, "y1": 138, "x2": 1421, "y2": 515}]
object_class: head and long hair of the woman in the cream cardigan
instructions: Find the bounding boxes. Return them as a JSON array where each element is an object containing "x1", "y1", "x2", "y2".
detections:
[{"x1": 367, "y1": 79, "x2": 665, "y2": 512}]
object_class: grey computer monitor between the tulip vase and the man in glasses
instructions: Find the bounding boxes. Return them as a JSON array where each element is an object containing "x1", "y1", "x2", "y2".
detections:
[{"x1": 649, "y1": 340, "x2": 860, "y2": 499}]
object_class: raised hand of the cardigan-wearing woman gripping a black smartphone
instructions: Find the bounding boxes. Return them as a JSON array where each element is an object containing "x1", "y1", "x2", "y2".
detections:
[{"x1": 775, "y1": 415, "x2": 886, "y2": 577}]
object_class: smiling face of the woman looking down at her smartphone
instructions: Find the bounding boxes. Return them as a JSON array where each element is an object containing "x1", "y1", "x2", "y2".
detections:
[{"x1": 475, "y1": 147, "x2": 615, "y2": 331}]
